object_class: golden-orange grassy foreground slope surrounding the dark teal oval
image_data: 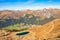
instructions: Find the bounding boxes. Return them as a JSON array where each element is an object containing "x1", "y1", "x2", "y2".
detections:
[{"x1": 0, "y1": 19, "x2": 60, "y2": 40}]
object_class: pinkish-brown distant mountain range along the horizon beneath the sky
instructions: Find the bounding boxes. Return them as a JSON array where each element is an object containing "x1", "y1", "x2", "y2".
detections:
[{"x1": 0, "y1": 8, "x2": 60, "y2": 19}]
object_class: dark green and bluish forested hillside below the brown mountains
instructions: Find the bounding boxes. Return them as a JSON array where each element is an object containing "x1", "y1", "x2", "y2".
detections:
[{"x1": 0, "y1": 14, "x2": 55, "y2": 28}]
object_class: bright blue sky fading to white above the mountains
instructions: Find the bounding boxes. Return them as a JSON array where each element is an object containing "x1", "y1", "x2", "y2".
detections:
[{"x1": 0, "y1": 0, "x2": 60, "y2": 10}]
